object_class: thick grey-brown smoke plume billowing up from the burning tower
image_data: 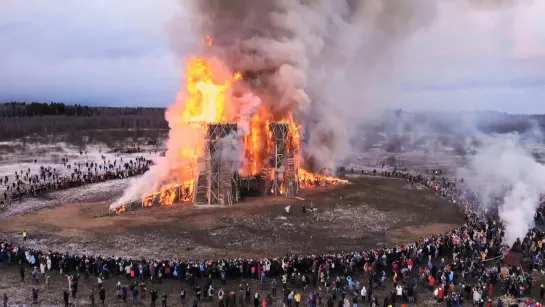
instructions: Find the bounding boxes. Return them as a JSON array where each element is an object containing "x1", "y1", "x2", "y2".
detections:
[{"x1": 174, "y1": 0, "x2": 436, "y2": 171}]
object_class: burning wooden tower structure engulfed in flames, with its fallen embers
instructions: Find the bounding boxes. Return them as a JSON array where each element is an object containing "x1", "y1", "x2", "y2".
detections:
[{"x1": 110, "y1": 54, "x2": 346, "y2": 213}]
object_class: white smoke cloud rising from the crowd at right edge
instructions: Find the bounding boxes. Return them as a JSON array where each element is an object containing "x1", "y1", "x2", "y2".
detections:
[{"x1": 458, "y1": 134, "x2": 545, "y2": 246}]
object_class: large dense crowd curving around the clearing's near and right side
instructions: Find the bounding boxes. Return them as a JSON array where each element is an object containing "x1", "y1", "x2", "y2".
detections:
[{"x1": 0, "y1": 172, "x2": 545, "y2": 307}]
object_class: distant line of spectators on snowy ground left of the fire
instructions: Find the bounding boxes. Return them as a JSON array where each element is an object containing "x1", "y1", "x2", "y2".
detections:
[{"x1": 0, "y1": 155, "x2": 153, "y2": 207}]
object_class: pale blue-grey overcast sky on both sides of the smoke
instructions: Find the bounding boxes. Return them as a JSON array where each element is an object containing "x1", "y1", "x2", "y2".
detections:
[{"x1": 0, "y1": 0, "x2": 545, "y2": 113}]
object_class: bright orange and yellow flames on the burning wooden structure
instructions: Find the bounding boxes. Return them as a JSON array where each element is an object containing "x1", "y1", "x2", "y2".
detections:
[{"x1": 112, "y1": 56, "x2": 346, "y2": 212}]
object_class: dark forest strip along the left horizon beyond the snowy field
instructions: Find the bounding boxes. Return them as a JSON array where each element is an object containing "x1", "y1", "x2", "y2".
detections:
[{"x1": 0, "y1": 102, "x2": 168, "y2": 145}]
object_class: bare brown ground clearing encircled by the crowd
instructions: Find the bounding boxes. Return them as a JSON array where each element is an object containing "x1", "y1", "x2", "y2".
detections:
[{"x1": 0, "y1": 177, "x2": 463, "y2": 259}]
